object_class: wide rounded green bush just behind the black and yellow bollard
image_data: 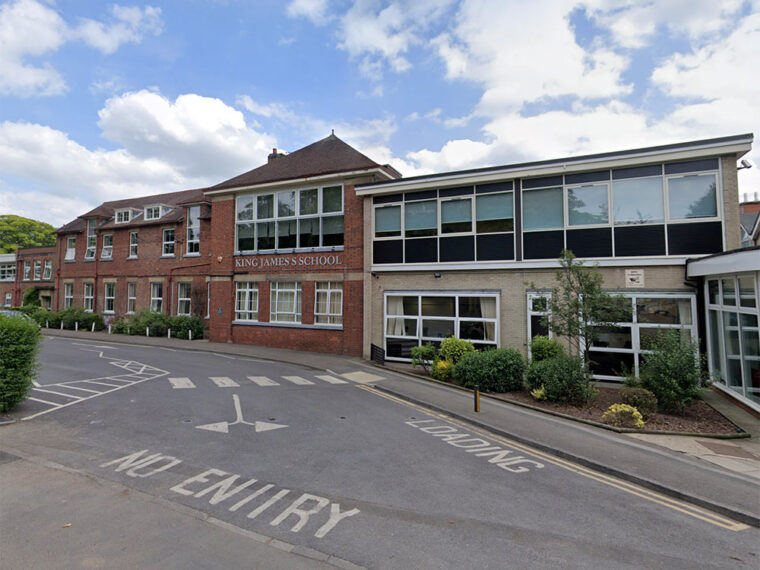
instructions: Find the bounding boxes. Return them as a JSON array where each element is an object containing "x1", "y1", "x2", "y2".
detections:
[{"x1": 454, "y1": 348, "x2": 525, "y2": 392}]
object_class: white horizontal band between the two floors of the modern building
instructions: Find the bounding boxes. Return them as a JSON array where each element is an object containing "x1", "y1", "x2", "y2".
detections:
[{"x1": 371, "y1": 257, "x2": 688, "y2": 273}]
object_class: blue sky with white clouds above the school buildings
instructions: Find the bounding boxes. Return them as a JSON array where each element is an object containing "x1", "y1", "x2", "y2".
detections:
[{"x1": 0, "y1": 0, "x2": 760, "y2": 225}]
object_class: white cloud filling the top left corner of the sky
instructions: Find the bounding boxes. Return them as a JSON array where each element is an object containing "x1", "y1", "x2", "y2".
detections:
[{"x1": 0, "y1": 0, "x2": 162, "y2": 97}]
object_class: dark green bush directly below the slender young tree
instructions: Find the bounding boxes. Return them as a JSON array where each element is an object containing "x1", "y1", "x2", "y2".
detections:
[{"x1": 526, "y1": 354, "x2": 595, "y2": 405}]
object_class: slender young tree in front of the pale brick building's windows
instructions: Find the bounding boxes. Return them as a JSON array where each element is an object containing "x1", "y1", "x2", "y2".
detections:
[{"x1": 547, "y1": 250, "x2": 631, "y2": 366}]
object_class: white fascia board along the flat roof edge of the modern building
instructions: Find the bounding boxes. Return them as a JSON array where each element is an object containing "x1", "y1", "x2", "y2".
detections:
[{"x1": 356, "y1": 138, "x2": 752, "y2": 196}]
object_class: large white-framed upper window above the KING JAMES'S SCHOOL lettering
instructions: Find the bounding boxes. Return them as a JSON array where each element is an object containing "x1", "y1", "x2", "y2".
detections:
[{"x1": 235, "y1": 186, "x2": 343, "y2": 252}]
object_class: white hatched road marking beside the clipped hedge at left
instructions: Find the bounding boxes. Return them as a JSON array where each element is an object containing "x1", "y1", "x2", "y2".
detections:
[{"x1": 21, "y1": 343, "x2": 169, "y2": 420}]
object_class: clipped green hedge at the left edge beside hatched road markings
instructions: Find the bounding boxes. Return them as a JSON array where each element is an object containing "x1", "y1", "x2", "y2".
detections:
[{"x1": 0, "y1": 315, "x2": 42, "y2": 412}]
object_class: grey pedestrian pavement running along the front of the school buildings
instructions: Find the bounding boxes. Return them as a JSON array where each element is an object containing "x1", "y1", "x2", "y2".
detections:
[{"x1": 38, "y1": 329, "x2": 760, "y2": 527}]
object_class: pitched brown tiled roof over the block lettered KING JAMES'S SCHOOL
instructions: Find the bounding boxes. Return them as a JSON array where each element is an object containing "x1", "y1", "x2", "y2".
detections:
[{"x1": 207, "y1": 134, "x2": 398, "y2": 191}]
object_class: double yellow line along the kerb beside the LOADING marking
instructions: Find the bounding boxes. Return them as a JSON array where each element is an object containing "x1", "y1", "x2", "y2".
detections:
[{"x1": 357, "y1": 386, "x2": 750, "y2": 532}]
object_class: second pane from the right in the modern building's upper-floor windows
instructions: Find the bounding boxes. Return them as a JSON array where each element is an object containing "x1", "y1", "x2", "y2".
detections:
[{"x1": 612, "y1": 177, "x2": 665, "y2": 224}]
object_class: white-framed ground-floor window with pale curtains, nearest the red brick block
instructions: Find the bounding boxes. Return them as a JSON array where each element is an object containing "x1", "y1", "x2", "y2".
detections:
[{"x1": 384, "y1": 291, "x2": 499, "y2": 360}]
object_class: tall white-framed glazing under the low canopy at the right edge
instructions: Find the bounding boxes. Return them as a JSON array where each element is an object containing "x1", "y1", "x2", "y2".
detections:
[{"x1": 705, "y1": 272, "x2": 760, "y2": 406}]
